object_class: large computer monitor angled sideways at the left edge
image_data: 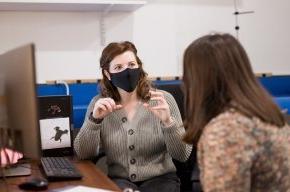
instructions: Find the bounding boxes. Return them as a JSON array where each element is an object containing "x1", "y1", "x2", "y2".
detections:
[{"x1": 0, "y1": 44, "x2": 40, "y2": 159}]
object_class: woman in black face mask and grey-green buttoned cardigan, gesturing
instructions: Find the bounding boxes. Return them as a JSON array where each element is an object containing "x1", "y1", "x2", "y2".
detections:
[{"x1": 75, "y1": 42, "x2": 191, "y2": 192}]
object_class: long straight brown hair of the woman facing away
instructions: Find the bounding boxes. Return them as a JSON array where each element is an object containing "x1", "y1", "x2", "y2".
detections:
[{"x1": 183, "y1": 34, "x2": 285, "y2": 144}]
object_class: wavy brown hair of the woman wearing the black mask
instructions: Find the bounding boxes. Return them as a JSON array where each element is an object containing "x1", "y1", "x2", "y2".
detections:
[{"x1": 100, "y1": 41, "x2": 151, "y2": 102}]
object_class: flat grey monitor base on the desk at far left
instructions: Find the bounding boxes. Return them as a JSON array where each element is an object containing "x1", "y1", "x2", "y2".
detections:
[{"x1": 0, "y1": 163, "x2": 31, "y2": 177}]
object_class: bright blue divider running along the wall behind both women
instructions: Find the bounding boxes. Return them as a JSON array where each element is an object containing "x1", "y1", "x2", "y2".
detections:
[{"x1": 37, "y1": 75, "x2": 290, "y2": 128}]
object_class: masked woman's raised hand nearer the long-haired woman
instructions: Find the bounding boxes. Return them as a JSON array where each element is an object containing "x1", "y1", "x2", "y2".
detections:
[{"x1": 143, "y1": 91, "x2": 173, "y2": 127}]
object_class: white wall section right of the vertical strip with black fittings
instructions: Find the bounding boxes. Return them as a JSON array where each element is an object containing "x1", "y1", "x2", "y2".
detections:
[{"x1": 240, "y1": 0, "x2": 290, "y2": 74}]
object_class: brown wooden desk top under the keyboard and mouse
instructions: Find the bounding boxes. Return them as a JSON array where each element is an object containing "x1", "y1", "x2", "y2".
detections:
[{"x1": 0, "y1": 160, "x2": 121, "y2": 192}]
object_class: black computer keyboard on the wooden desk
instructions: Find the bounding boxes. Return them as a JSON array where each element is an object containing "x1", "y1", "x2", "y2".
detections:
[{"x1": 40, "y1": 157, "x2": 82, "y2": 181}]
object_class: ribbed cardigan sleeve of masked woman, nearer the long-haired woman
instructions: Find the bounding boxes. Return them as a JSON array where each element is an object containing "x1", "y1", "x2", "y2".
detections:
[{"x1": 162, "y1": 91, "x2": 192, "y2": 162}]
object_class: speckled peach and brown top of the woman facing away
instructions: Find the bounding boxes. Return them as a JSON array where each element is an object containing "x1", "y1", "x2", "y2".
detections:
[{"x1": 198, "y1": 108, "x2": 290, "y2": 192}]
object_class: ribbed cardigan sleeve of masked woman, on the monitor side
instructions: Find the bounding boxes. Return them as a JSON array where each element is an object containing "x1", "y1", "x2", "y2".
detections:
[{"x1": 74, "y1": 96, "x2": 103, "y2": 159}]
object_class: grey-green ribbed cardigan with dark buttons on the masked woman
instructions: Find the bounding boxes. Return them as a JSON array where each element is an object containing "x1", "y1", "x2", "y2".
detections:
[{"x1": 74, "y1": 91, "x2": 192, "y2": 182}]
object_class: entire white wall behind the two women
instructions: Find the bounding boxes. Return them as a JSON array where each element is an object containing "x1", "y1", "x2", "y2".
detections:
[{"x1": 0, "y1": 0, "x2": 290, "y2": 82}]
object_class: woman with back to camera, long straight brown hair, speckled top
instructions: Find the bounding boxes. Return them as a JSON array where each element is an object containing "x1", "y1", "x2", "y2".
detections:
[{"x1": 183, "y1": 34, "x2": 290, "y2": 192}]
